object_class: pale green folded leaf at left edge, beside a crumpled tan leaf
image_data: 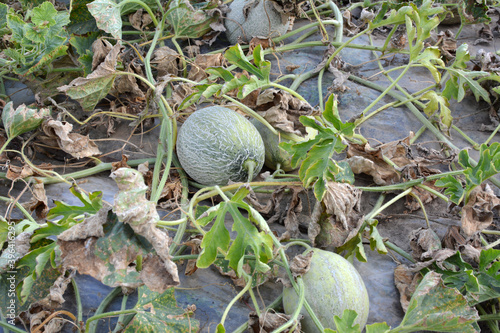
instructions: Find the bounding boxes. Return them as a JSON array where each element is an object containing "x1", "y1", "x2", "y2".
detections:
[{"x1": 2, "y1": 102, "x2": 50, "y2": 139}]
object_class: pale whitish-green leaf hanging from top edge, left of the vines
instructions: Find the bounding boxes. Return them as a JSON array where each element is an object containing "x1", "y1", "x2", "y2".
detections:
[{"x1": 87, "y1": 0, "x2": 122, "y2": 39}]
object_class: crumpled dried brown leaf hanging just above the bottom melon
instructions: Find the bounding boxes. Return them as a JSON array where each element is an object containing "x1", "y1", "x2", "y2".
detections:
[{"x1": 307, "y1": 182, "x2": 363, "y2": 247}]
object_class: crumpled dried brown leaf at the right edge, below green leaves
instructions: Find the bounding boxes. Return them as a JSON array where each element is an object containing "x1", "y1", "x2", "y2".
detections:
[{"x1": 461, "y1": 183, "x2": 500, "y2": 237}]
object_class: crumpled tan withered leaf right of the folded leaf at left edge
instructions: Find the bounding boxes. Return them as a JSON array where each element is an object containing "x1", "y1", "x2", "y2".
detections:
[{"x1": 42, "y1": 119, "x2": 101, "y2": 158}]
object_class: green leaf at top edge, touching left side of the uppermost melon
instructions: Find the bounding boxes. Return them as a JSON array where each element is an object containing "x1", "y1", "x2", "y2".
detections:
[{"x1": 165, "y1": 0, "x2": 218, "y2": 38}]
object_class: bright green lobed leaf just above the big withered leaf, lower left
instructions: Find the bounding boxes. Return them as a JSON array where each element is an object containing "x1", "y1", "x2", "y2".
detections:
[{"x1": 47, "y1": 186, "x2": 102, "y2": 220}]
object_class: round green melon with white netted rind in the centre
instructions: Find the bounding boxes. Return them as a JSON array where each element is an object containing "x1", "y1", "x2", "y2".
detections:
[{"x1": 176, "y1": 106, "x2": 265, "y2": 185}]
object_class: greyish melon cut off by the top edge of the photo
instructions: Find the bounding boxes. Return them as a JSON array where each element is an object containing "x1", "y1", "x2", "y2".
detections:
[{"x1": 224, "y1": 0, "x2": 289, "y2": 44}]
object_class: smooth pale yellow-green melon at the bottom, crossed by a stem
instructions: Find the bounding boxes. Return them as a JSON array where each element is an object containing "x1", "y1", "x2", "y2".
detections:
[{"x1": 283, "y1": 249, "x2": 369, "y2": 333}]
